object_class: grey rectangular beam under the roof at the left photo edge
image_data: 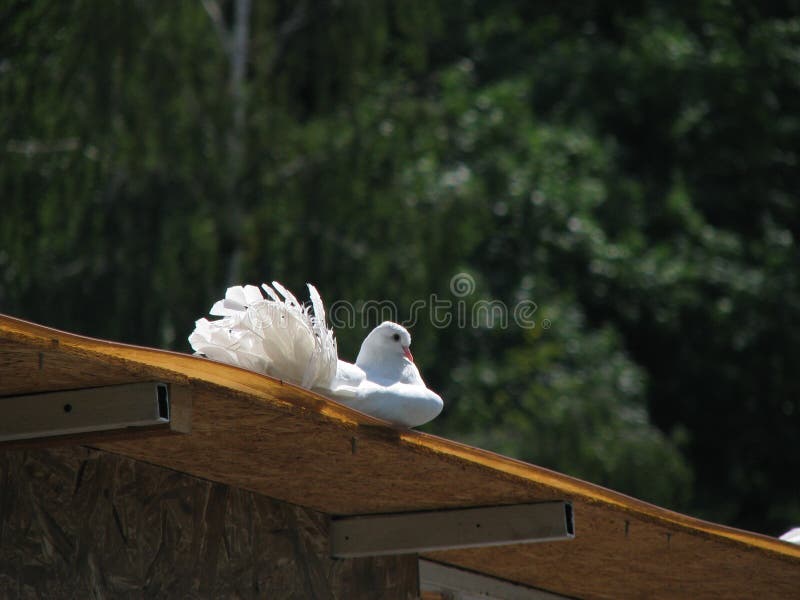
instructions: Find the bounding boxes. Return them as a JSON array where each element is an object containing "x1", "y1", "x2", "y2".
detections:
[{"x1": 0, "y1": 382, "x2": 170, "y2": 442}]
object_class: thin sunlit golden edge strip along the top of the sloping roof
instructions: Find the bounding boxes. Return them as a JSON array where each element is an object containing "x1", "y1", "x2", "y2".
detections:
[{"x1": 0, "y1": 314, "x2": 800, "y2": 560}]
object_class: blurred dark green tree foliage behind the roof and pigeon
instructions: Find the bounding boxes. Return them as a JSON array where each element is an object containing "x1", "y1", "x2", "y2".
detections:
[{"x1": 0, "y1": 0, "x2": 800, "y2": 533}]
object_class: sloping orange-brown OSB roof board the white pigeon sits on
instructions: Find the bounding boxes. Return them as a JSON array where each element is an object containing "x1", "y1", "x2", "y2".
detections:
[{"x1": 0, "y1": 317, "x2": 800, "y2": 598}]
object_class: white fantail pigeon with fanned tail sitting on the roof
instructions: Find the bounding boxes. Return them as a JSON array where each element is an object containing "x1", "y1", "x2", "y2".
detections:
[{"x1": 189, "y1": 281, "x2": 444, "y2": 427}]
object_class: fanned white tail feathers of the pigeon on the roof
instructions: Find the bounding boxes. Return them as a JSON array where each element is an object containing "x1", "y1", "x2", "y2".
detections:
[{"x1": 189, "y1": 281, "x2": 338, "y2": 389}]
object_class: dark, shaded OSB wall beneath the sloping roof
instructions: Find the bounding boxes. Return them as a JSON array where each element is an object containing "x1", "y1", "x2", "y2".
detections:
[{"x1": 0, "y1": 446, "x2": 418, "y2": 600}]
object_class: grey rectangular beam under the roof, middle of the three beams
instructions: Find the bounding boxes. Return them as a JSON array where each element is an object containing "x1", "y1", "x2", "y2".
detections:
[{"x1": 331, "y1": 502, "x2": 574, "y2": 558}]
